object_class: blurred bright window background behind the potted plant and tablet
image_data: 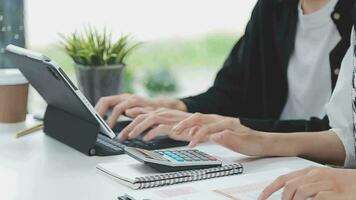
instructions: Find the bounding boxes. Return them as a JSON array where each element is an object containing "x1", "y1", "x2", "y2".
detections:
[{"x1": 0, "y1": 0, "x2": 256, "y2": 112}]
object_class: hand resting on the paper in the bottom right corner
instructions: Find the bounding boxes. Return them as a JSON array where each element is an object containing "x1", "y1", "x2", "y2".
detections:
[{"x1": 259, "y1": 167, "x2": 356, "y2": 200}]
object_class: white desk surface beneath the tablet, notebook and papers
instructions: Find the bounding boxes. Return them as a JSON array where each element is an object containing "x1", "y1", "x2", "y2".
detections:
[{"x1": 0, "y1": 117, "x2": 317, "y2": 200}]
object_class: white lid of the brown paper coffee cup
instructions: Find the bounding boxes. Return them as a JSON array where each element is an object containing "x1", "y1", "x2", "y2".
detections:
[{"x1": 0, "y1": 69, "x2": 28, "y2": 85}]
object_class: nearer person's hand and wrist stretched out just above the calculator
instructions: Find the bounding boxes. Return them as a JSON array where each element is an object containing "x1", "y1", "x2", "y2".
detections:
[{"x1": 173, "y1": 113, "x2": 300, "y2": 156}]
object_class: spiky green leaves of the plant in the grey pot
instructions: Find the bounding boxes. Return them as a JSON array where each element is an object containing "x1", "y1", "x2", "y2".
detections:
[{"x1": 60, "y1": 26, "x2": 141, "y2": 67}]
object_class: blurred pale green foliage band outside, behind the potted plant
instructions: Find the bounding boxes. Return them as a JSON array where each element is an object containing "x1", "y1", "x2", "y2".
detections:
[{"x1": 34, "y1": 33, "x2": 239, "y2": 92}]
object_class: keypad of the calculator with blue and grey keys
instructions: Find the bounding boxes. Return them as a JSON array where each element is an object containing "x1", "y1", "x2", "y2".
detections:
[{"x1": 154, "y1": 149, "x2": 217, "y2": 162}]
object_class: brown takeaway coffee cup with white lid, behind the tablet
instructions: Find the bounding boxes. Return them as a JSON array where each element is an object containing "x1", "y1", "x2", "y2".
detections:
[{"x1": 0, "y1": 69, "x2": 29, "y2": 123}]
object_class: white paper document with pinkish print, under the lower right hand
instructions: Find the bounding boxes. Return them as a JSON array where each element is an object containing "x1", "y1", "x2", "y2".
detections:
[{"x1": 129, "y1": 168, "x2": 292, "y2": 200}]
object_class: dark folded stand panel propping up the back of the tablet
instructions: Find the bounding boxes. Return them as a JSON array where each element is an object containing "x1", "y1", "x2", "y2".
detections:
[{"x1": 44, "y1": 105, "x2": 100, "y2": 156}]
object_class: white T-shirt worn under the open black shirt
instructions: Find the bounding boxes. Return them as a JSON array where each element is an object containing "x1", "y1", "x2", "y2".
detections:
[{"x1": 280, "y1": 0, "x2": 341, "y2": 120}]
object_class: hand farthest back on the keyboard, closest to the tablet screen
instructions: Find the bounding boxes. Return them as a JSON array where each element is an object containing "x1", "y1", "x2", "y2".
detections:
[{"x1": 95, "y1": 93, "x2": 186, "y2": 127}]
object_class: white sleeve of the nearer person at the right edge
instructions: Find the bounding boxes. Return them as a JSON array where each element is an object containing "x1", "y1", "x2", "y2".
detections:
[{"x1": 326, "y1": 31, "x2": 356, "y2": 168}]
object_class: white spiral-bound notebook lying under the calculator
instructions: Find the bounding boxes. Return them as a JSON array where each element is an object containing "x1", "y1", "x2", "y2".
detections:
[{"x1": 96, "y1": 159, "x2": 243, "y2": 190}]
